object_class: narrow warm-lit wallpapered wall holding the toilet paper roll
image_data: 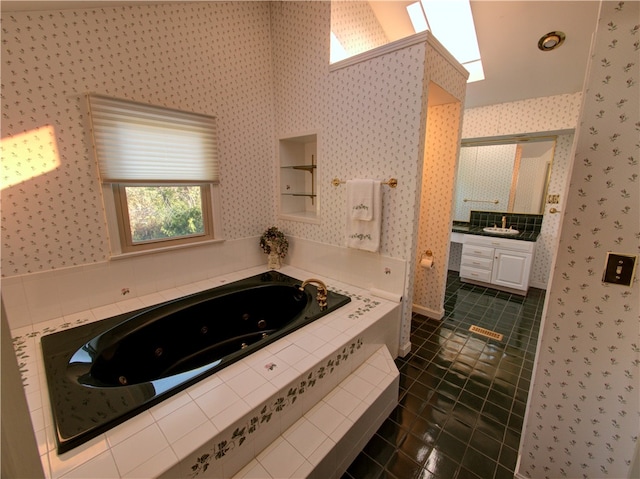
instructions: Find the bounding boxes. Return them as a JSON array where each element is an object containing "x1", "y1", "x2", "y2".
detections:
[{"x1": 403, "y1": 37, "x2": 468, "y2": 322}]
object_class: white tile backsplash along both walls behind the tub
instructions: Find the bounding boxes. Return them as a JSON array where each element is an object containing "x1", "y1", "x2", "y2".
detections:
[{"x1": 2, "y1": 236, "x2": 406, "y2": 330}]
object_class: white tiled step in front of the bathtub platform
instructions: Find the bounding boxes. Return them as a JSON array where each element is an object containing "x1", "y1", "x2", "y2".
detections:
[{"x1": 233, "y1": 346, "x2": 400, "y2": 479}]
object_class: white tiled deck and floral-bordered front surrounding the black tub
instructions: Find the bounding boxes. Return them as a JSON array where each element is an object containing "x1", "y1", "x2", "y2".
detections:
[{"x1": 12, "y1": 266, "x2": 400, "y2": 479}]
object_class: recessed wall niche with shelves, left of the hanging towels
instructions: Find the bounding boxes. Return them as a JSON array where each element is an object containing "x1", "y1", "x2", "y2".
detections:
[{"x1": 279, "y1": 133, "x2": 320, "y2": 222}]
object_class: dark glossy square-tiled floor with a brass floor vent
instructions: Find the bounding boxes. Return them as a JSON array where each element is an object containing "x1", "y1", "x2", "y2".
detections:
[{"x1": 342, "y1": 271, "x2": 545, "y2": 479}]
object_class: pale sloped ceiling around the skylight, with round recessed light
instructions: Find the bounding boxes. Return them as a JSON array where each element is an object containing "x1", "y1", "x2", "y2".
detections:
[{"x1": 1, "y1": 0, "x2": 600, "y2": 108}]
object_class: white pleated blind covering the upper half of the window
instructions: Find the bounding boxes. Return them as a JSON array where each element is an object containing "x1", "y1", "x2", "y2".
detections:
[{"x1": 87, "y1": 94, "x2": 219, "y2": 183}]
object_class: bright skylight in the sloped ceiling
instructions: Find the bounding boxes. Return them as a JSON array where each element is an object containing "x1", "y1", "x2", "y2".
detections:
[{"x1": 407, "y1": 0, "x2": 484, "y2": 83}]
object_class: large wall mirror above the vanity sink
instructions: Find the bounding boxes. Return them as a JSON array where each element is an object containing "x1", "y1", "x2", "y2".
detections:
[{"x1": 453, "y1": 137, "x2": 556, "y2": 222}]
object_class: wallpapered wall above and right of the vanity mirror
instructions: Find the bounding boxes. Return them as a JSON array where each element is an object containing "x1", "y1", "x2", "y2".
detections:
[{"x1": 462, "y1": 92, "x2": 582, "y2": 289}]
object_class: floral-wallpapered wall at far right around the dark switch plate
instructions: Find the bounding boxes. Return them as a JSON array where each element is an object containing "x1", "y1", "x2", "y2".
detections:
[{"x1": 518, "y1": 1, "x2": 640, "y2": 479}]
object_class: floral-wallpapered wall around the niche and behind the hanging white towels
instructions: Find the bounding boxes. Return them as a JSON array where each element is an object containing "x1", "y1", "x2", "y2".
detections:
[{"x1": 272, "y1": 2, "x2": 465, "y2": 356}]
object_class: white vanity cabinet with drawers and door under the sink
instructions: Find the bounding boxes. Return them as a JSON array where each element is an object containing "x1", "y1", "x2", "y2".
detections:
[{"x1": 460, "y1": 235, "x2": 535, "y2": 294}]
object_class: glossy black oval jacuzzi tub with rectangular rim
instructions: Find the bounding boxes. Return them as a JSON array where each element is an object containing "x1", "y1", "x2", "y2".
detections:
[{"x1": 42, "y1": 271, "x2": 350, "y2": 453}]
